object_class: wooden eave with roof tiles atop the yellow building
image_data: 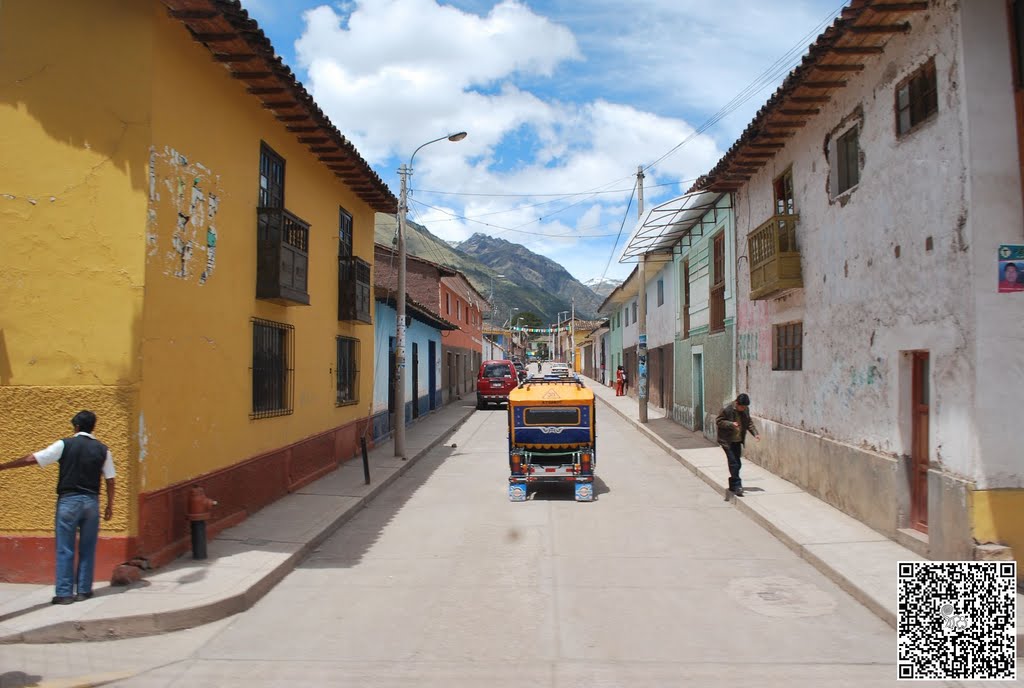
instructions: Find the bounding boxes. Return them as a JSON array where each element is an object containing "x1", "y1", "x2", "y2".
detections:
[{"x1": 162, "y1": 0, "x2": 398, "y2": 215}]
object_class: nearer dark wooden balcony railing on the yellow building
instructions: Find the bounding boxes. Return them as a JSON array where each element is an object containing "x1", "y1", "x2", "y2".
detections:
[{"x1": 256, "y1": 208, "x2": 309, "y2": 306}]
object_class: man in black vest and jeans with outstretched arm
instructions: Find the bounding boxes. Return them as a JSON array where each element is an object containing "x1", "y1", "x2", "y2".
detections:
[{"x1": 0, "y1": 411, "x2": 115, "y2": 604}]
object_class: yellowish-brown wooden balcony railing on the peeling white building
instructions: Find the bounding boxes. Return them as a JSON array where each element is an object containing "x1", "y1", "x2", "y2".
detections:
[{"x1": 746, "y1": 215, "x2": 804, "y2": 301}]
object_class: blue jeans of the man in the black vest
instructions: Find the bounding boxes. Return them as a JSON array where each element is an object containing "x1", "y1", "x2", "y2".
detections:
[{"x1": 56, "y1": 495, "x2": 99, "y2": 597}]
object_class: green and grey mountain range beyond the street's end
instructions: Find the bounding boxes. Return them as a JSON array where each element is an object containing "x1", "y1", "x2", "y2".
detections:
[{"x1": 374, "y1": 214, "x2": 598, "y2": 326}]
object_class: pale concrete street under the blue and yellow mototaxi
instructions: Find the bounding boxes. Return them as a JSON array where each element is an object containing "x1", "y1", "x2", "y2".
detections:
[{"x1": 0, "y1": 384, "x2": 974, "y2": 688}]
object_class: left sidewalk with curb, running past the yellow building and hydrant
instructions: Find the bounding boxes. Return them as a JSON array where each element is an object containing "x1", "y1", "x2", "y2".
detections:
[{"x1": 0, "y1": 395, "x2": 475, "y2": 644}]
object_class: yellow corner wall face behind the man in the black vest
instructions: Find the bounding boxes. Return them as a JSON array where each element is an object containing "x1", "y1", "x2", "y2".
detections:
[{"x1": 0, "y1": 0, "x2": 155, "y2": 534}]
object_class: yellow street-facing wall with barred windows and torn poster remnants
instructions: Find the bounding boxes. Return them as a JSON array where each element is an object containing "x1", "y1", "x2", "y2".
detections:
[{"x1": 140, "y1": 13, "x2": 374, "y2": 492}]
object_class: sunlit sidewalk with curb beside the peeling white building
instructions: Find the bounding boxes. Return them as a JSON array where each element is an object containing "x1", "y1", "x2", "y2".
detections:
[{"x1": 584, "y1": 370, "x2": 1024, "y2": 656}]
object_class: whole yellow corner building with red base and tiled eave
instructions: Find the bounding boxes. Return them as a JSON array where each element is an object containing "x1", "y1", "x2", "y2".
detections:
[{"x1": 0, "y1": 0, "x2": 396, "y2": 582}]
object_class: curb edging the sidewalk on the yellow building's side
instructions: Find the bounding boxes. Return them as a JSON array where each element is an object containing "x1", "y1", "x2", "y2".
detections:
[{"x1": 0, "y1": 406, "x2": 475, "y2": 645}]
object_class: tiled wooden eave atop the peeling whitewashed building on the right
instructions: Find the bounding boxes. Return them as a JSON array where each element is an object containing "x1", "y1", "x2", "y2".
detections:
[{"x1": 689, "y1": 0, "x2": 930, "y2": 192}]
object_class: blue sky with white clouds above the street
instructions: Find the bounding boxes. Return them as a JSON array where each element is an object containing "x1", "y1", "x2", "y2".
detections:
[{"x1": 242, "y1": 0, "x2": 843, "y2": 281}]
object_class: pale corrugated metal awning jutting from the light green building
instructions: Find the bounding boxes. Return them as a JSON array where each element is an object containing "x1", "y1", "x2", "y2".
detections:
[{"x1": 618, "y1": 191, "x2": 732, "y2": 263}]
